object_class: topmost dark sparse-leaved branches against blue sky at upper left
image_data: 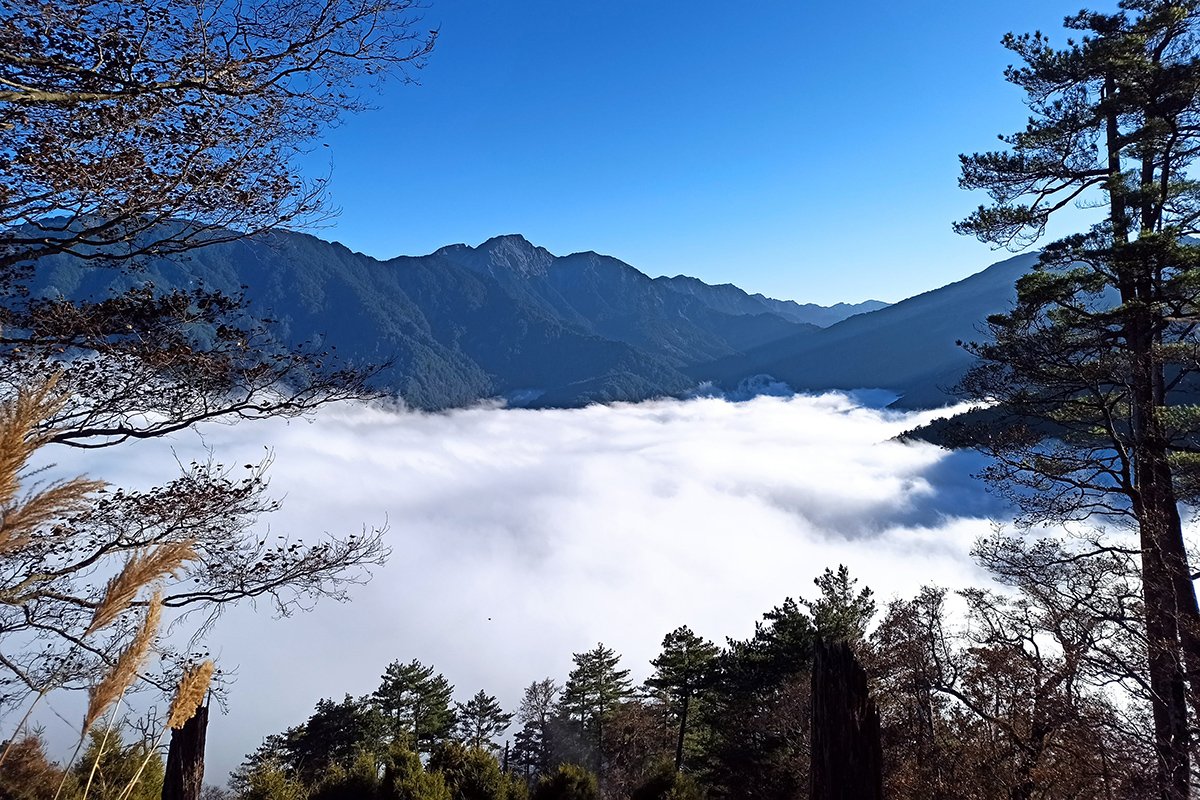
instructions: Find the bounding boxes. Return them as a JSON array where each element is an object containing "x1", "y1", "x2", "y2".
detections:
[{"x1": 0, "y1": 0, "x2": 436, "y2": 267}]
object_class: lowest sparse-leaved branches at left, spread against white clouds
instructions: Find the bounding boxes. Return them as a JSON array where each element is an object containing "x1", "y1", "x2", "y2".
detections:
[{"x1": 0, "y1": 379, "x2": 386, "y2": 711}]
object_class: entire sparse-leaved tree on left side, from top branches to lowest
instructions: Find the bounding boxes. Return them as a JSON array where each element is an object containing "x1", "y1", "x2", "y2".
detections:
[{"x1": 0, "y1": 0, "x2": 436, "y2": 724}]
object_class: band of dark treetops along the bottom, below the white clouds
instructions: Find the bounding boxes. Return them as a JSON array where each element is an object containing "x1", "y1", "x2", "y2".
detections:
[{"x1": 0, "y1": 556, "x2": 1154, "y2": 800}]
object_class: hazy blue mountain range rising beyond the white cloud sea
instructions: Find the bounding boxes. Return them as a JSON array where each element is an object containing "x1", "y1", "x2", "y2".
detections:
[{"x1": 23, "y1": 231, "x2": 1036, "y2": 409}]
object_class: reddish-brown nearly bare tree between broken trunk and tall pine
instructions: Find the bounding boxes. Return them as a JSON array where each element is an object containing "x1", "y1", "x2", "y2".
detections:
[{"x1": 870, "y1": 535, "x2": 1154, "y2": 800}]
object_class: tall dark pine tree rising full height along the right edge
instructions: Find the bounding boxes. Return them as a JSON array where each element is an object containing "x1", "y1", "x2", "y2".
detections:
[{"x1": 956, "y1": 0, "x2": 1200, "y2": 800}]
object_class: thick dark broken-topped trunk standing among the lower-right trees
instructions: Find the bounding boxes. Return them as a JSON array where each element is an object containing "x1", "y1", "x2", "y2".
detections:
[{"x1": 809, "y1": 642, "x2": 883, "y2": 800}]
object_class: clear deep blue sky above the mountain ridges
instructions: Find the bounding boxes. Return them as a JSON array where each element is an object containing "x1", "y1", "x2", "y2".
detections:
[{"x1": 314, "y1": 0, "x2": 1115, "y2": 303}]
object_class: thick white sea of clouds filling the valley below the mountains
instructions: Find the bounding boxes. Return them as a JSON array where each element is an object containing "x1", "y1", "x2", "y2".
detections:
[{"x1": 25, "y1": 395, "x2": 1009, "y2": 781}]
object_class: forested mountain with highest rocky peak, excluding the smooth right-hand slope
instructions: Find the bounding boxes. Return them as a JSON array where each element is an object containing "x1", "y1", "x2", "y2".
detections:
[{"x1": 32, "y1": 233, "x2": 854, "y2": 409}]
